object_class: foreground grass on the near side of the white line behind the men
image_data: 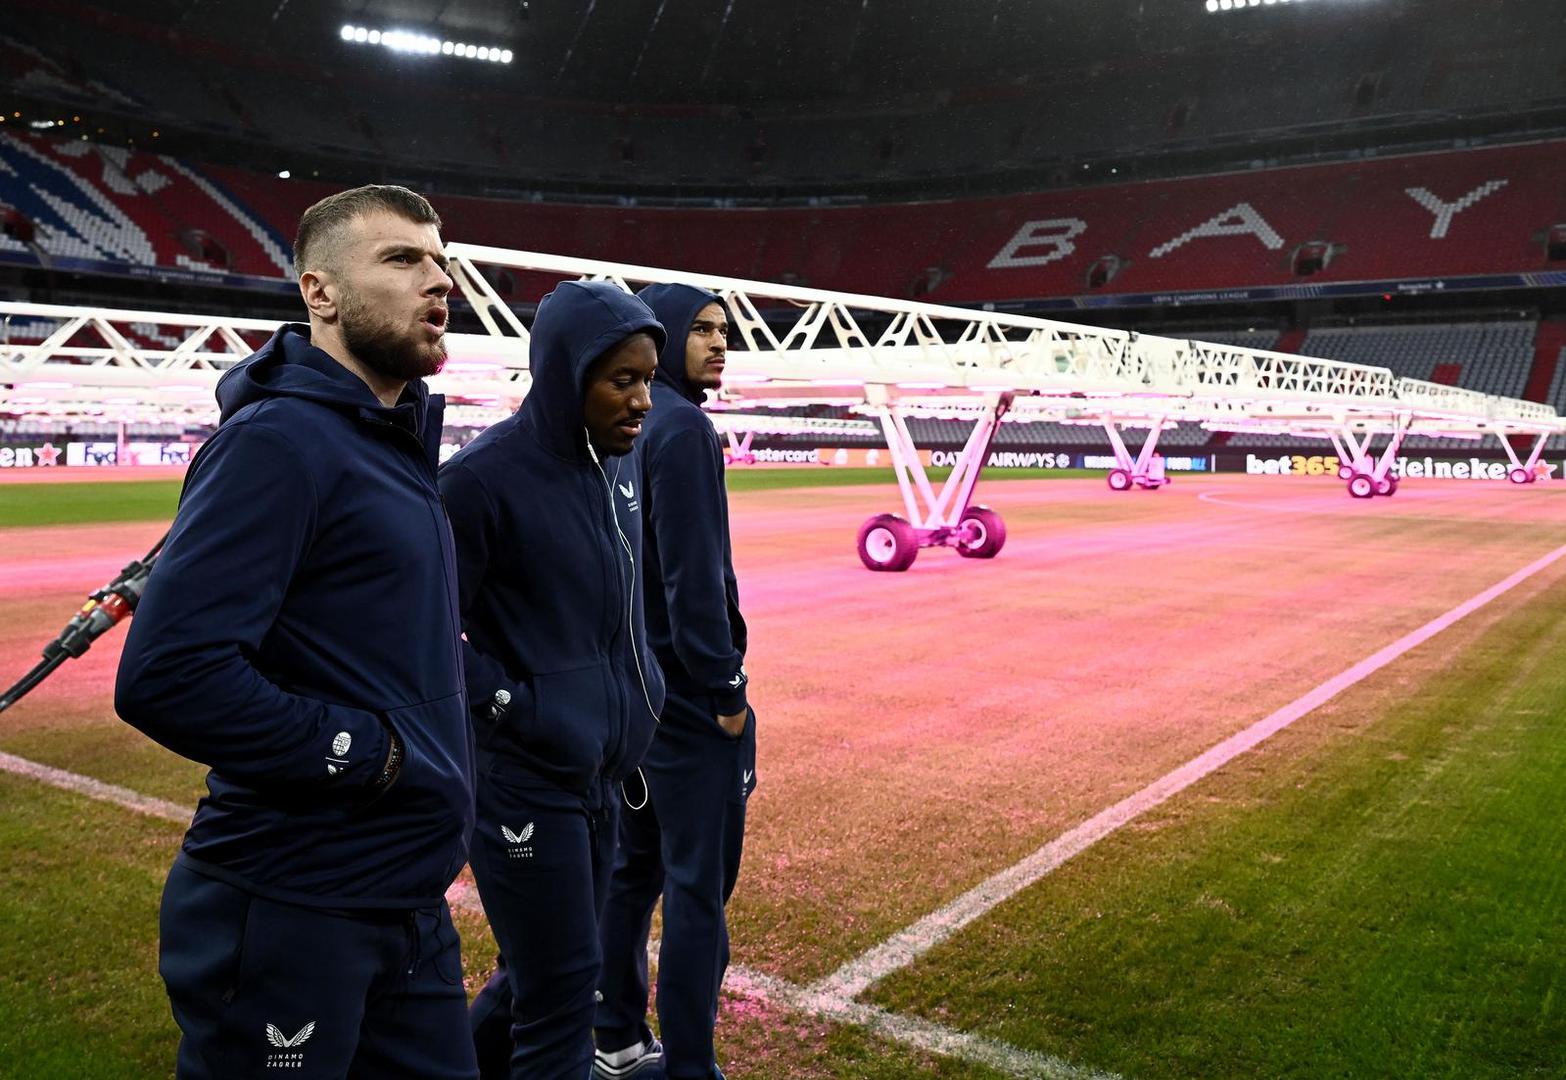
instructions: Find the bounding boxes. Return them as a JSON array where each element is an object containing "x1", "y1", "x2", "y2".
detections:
[{"x1": 0, "y1": 773, "x2": 1001, "y2": 1080}]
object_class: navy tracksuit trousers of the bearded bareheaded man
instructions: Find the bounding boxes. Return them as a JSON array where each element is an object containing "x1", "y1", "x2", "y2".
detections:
[{"x1": 158, "y1": 862, "x2": 478, "y2": 1080}]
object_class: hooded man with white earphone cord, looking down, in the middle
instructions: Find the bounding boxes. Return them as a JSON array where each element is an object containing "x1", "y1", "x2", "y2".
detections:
[{"x1": 440, "y1": 282, "x2": 664, "y2": 1080}]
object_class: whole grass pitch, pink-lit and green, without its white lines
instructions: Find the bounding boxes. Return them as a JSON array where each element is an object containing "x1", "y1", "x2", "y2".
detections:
[{"x1": 0, "y1": 468, "x2": 1566, "y2": 1080}]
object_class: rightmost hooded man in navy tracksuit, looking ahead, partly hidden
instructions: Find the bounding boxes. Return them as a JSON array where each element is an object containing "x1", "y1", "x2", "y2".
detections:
[{"x1": 594, "y1": 285, "x2": 756, "y2": 1080}]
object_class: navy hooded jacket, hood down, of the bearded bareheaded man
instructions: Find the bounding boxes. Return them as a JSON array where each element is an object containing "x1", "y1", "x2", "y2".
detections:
[{"x1": 114, "y1": 326, "x2": 473, "y2": 908}]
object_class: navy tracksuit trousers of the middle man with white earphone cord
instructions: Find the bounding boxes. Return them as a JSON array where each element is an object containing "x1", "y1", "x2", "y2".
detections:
[{"x1": 468, "y1": 769, "x2": 620, "y2": 1080}]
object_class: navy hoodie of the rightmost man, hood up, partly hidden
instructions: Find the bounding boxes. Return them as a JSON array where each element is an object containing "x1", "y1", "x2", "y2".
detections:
[{"x1": 637, "y1": 285, "x2": 747, "y2": 720}]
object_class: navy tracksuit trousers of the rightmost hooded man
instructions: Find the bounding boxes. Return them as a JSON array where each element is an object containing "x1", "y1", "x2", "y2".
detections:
[{"x1": 594, "y1": 692, "x2": 756, "y2": 1080}]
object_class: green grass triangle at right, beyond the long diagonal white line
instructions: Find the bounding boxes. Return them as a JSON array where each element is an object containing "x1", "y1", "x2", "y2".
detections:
[{"x1": 871, "y1": 572, "x2": 1566, "y2": 1078}]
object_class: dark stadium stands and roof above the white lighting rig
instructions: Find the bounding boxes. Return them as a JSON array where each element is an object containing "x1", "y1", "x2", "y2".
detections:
[{"x1": 0, "y1": 0, "x2": 1566, "y2": 437}]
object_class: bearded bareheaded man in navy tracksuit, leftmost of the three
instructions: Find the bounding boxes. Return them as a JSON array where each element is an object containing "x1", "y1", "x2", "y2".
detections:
[{"x1": 114, "y1": 188, "x2": 476, "y2": 1080}]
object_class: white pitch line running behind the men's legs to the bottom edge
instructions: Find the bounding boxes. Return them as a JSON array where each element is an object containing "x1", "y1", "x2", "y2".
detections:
[{"x1": 0, "y1": 751, "x2": 1120, "y2": 1080}]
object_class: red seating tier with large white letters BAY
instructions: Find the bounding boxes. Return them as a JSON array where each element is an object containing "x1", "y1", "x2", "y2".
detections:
[{"x1": 0, "y1": 131, "x2": 1566, "y2": 304}]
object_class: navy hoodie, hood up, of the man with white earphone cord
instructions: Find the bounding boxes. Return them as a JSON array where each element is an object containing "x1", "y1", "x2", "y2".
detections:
[{"x1": 440, "y1": 282, "x2": 664, "y2": 798}]
